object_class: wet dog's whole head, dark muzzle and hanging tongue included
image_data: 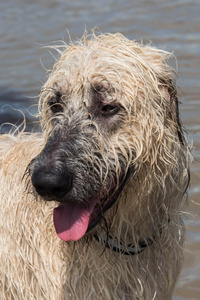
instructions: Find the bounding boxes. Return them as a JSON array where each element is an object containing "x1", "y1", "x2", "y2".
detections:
[{"x1": 29, "y1": 35, "x2": 183, "y2": 241}]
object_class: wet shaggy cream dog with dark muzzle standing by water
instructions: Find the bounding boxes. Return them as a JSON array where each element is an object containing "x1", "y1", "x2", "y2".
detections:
[{"x1": 0, "y1": 34, "x2": 189, "y2": 300}]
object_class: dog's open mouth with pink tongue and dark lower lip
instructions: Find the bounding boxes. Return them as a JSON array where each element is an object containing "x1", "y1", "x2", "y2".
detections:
[{"x1": 53, "y1": 171, "x2": 127, "y2": 241}]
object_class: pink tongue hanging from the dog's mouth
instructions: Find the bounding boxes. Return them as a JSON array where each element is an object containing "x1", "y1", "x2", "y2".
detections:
[{"x1": 53, "y1": 199, "x2": 97, "y2": 241}]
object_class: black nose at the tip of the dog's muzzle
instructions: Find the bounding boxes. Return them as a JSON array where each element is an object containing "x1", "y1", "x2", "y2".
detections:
[{"x1": 32, "y1": 168, "x2": 72, "y2": 198}]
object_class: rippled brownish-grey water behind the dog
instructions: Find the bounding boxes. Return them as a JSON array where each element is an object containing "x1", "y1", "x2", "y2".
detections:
[{"x1": 0, "y1": 0, "x2": 200, "y2": 300}]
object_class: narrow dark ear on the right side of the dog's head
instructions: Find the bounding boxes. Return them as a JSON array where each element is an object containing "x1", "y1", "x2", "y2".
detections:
[{"x1": 161, "y1": 79, "x2": 185, "y2": 145}]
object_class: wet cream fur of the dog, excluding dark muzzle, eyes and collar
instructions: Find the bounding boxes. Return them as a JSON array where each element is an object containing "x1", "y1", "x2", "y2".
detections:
[{"x1": 0, "y1": 34, "x2": 189, "y2": 300}]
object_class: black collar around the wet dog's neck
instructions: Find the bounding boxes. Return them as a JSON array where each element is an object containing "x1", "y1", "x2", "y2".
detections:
[{"x1": 94, "y1": 233, "x2": 153, "y2": 255}]
